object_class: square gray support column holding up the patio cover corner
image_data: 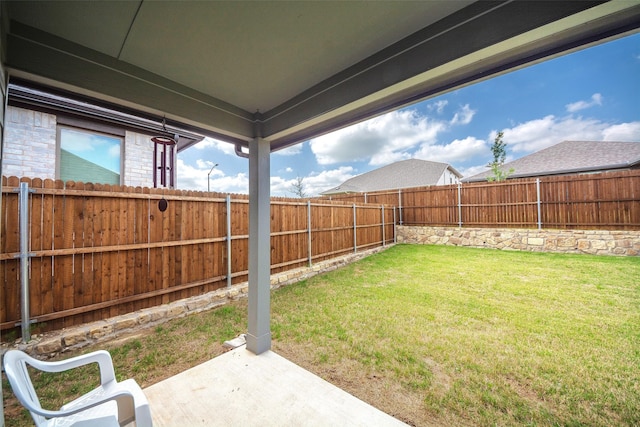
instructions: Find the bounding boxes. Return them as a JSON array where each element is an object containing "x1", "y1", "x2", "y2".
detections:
[{"x1": 247, "y1": 138, "x2": 271, "y2": 354}]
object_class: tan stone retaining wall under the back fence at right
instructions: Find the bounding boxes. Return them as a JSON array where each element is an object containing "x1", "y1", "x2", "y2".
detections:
[{"x1": 396, "y1": 225, "x2": 640, "y2": 256}]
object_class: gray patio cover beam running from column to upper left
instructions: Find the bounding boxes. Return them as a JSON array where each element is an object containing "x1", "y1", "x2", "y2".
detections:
[{"x1": 5, "y1": 21, "x2": 254, "y2": 143}]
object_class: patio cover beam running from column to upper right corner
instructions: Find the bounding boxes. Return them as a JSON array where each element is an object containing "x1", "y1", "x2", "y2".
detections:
[{"x1": 264, "y1": 1, "x2": 640, "y2": 149}]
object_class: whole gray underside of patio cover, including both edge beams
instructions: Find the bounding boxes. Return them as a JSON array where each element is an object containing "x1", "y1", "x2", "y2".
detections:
[{"x1": 2, "y1": 0, "x2": 640, "y2": 151}]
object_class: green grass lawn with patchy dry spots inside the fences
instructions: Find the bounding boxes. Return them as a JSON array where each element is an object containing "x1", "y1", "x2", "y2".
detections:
[{"x1": 3, "y1": 245, "x2": 640, "y2": 426}]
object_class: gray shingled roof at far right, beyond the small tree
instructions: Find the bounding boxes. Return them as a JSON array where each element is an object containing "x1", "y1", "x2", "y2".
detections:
[{"x1": 462, "y1": 141, "x2": 640, "y2": 182}]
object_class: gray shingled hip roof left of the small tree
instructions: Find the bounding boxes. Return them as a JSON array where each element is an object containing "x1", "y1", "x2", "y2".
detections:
[{"x1": 320, "y1": 159, "x2": 462, "y2": 195}]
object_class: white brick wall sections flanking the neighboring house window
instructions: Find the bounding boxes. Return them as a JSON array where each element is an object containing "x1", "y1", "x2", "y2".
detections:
[{"x1": 2, "y1": 107, "x2": 153, "y2": 187}]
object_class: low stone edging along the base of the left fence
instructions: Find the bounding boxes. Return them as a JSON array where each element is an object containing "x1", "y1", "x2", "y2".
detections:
[{"x1": 0, "y1": 245, "x2": 392, "y2": 358}]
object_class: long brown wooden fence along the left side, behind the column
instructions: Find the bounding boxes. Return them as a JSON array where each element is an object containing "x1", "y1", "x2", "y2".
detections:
[{"x1": 0, "y1": 177, "x2": 395, "y2": 338}]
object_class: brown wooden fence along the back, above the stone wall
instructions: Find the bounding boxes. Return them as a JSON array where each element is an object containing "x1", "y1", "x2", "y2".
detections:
[{"x1": 331, "y1": 170, "x2": 640, "y2": 230}]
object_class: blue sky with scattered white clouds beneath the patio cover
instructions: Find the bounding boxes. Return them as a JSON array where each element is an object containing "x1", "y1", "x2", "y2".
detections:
[{"x1": 178, "y1": 34, "x2": 640, "y2": 197}]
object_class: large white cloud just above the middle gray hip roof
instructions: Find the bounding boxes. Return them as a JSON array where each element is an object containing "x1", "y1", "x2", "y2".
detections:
[{"x1": 310, "y1": 110, "x2": 446, "y2": 165}]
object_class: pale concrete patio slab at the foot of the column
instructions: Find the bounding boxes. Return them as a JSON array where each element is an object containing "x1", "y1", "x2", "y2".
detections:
[{"x1": 144, "y1": 346, "x2": 406, "y2": 427}]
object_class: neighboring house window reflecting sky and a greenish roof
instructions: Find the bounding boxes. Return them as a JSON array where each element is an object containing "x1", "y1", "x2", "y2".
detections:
[{"x1": 58, "y1": 126, "x2": 123, "y2": 185}]
